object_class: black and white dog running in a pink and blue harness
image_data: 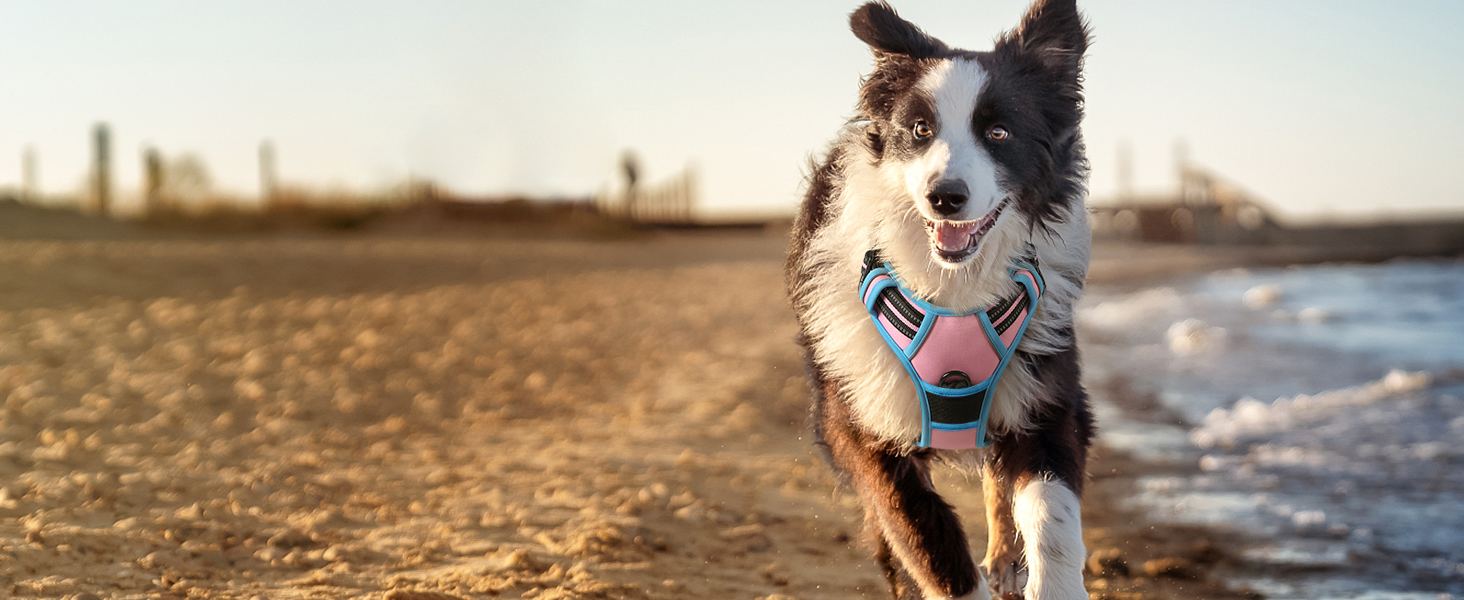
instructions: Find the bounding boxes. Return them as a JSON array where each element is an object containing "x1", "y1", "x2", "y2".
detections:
[{"x1": 786, "y1": 0, "x2": 1094, "y2": 600}]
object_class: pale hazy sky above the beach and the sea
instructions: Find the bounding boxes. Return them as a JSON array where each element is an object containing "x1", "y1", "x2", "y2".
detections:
[{"x1": 0, "y1": 0, "x2": 1464, "y2": 220}]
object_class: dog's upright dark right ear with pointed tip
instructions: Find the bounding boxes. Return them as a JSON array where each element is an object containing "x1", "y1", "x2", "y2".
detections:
[{"x1": 997, "y1": 0, "x2": 1089, "y2": 80}]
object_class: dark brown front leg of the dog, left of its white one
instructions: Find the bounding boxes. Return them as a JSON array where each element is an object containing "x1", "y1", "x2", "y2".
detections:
[{"x1": 821, "y1": 402, "x2": 990, "y2": 600}]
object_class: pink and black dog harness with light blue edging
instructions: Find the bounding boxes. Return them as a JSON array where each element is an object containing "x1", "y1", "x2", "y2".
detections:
[{"x1": 859, "y1": 250, "x2": 1044, "y2": 449}]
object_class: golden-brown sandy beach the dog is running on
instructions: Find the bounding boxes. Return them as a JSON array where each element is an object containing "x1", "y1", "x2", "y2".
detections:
[{"x1": 0, "y1": 213, "x2": 1259, "y2": 600}]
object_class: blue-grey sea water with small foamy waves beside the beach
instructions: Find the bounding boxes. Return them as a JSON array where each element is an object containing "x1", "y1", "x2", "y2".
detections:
[{"x1": 1078, "y1": 260, "x2": 1464, "y2": 599}]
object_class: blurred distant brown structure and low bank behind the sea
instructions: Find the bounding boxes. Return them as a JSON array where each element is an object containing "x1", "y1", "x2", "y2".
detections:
[{"x1": 1089, "y1": 140, "x2": 1464, "y2": 256}]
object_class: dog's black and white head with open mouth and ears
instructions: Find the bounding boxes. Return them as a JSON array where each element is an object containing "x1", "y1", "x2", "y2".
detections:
[{"x1": 849, "y1": 0, "x2": 1088, "y2": 269}]
